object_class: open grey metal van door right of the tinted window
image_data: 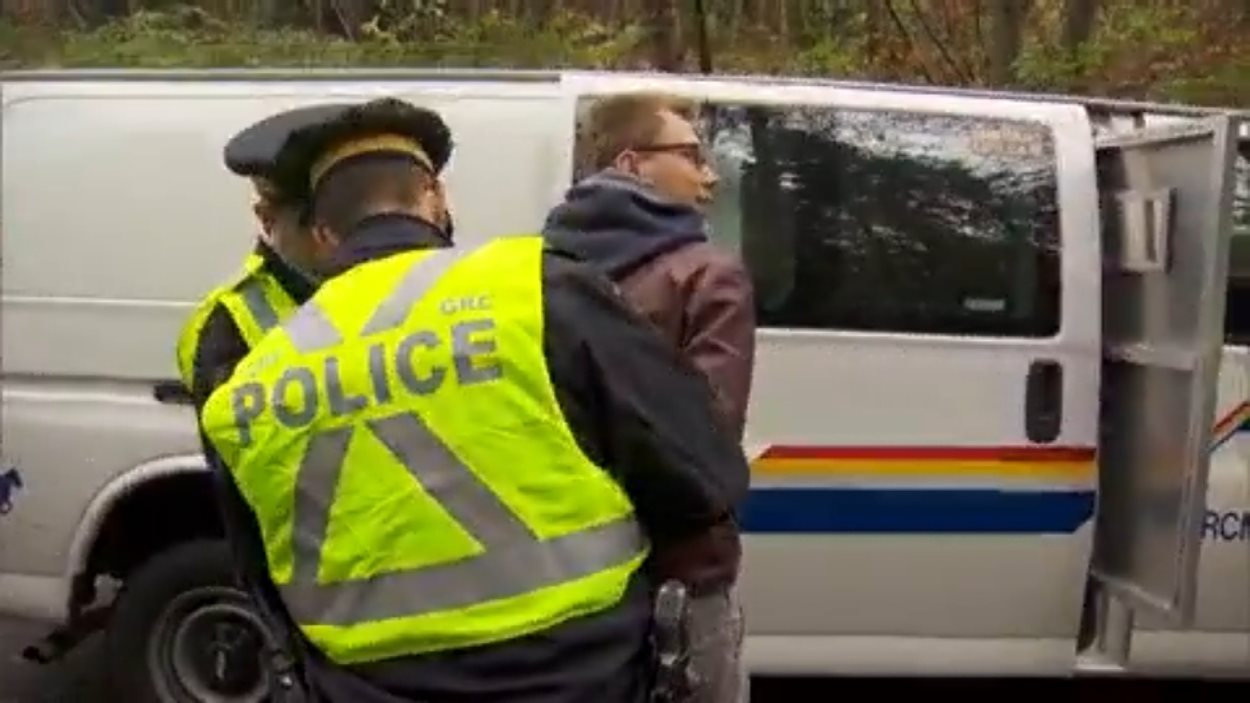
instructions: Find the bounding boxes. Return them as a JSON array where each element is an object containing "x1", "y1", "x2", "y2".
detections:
[{"x1": 1093, "y1": 113, "x2": 1239, "y2": 650}]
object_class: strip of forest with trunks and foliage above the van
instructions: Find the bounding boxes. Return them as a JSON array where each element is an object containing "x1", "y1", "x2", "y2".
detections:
[{"x1": 0, "y1": 0, "x2": 1250, "y2": 108}]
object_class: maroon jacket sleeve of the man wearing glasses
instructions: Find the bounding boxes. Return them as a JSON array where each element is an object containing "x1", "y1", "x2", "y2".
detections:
[{"x1": 681, "y1": 246, "x2": 755, "y2": 440}]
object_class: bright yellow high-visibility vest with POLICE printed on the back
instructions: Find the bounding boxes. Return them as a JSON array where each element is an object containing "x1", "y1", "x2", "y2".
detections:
[{"x1": 204, "y1": 238, "x2": 646, "y2": 663}]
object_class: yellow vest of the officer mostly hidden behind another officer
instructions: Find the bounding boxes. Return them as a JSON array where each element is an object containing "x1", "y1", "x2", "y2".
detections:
[{"x1": 178, "y1": 253, "x2": 296, "y2": 388}]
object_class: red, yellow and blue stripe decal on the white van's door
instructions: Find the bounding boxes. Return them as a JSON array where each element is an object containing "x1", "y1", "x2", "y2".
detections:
[{"x1": 743, "y1": 447, "x2": 1096, "y2": 534}]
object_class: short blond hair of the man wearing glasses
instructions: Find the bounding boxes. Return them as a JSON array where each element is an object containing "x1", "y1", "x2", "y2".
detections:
[{"x1": 578, "y1": 91, "x2": 699, "y2": 171}]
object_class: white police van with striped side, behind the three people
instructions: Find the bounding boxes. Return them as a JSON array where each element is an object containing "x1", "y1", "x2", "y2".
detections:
[{"x1": 0, "y1": 71, "x2": 1250, "y2": 700}]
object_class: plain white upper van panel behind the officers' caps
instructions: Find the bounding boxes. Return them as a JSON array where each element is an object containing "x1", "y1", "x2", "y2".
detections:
[{"x1": 3, "y1": 81, "x2": 573, "y2": 380}]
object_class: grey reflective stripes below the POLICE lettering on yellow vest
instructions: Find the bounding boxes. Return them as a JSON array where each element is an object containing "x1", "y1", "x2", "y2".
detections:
[{"x1": 281, "y1": 414, "x2": 640, "y2": 625}]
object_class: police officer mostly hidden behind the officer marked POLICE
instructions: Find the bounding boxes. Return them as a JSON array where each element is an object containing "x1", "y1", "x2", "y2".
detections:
[{"x1": 176, "y1": 105, "x2": 355, "y2": 698}]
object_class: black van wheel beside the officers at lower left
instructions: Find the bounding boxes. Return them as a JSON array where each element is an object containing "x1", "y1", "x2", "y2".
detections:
[{"x1": 105, "y1": 540, "x2": 268, "y2": 703}]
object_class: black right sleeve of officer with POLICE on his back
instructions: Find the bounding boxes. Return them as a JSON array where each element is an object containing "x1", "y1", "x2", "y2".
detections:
[{"x1": 544, "y1": 254, "x2": 750, "y2": 543}]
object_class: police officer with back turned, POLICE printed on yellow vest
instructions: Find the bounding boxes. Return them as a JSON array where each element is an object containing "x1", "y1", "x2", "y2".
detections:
[{"x1": 203, "y1": 99, "x2": 748, "y2": 703}]
